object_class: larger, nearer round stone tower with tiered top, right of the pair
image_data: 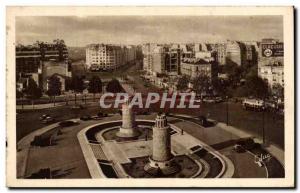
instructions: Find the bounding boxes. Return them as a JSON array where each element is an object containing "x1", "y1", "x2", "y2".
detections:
[{"x1": 144, "y1": 114, "x2": 180, "y2": 176}]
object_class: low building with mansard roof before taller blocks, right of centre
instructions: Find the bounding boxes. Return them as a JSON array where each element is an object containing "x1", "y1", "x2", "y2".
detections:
[{"x1": 180, "y1": 58, "x2": 217, "y2": 80}]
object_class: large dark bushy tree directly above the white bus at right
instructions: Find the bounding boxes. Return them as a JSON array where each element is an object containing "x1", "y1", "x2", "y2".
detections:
[{"x1": 243, "y1": 75, "x2": 269, "y2": 99}]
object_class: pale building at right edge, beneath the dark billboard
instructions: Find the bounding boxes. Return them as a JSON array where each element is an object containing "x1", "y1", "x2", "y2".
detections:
[{"x1": 258, "y1": 64, "x2": 284, "y2": 88}]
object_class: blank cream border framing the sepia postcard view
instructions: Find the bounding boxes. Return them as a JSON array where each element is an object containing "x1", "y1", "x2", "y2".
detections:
[{"x1": 6, "y1": 7, "x2": 294, "y2": 187}]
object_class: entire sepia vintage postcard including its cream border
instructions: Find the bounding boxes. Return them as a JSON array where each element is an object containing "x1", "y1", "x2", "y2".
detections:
[{"x1": 6, "y1": 6, "x2": 295, "y2": 188}]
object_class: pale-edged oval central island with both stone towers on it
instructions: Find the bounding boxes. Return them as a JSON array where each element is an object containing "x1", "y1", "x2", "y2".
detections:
[{"x1": 77, "y1": 100, "x2": 234, "y2": 178}]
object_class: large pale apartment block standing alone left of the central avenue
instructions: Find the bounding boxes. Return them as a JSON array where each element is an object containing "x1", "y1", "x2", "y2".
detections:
[{"x1": 86, "y1": 44, "x2": 136, "y2": 70}]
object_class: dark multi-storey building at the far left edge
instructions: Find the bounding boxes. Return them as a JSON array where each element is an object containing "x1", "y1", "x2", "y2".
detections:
[{"x1": 16, "y1": 40, "x2": 71, "y2": 89}]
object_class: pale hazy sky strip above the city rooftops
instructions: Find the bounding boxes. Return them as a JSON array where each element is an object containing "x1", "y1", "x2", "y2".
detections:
[{"x1": 16, "y1": 16, "x2": 283, "y2": 46}]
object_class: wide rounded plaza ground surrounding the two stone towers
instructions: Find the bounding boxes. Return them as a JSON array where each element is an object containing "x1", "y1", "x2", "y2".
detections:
[{"x1": 17, "y1": 105, "x2": 284, "y2": 178}]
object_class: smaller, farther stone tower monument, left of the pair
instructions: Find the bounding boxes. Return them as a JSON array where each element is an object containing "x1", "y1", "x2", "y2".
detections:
[{"x1": 116, "y1": 100, "x2": 139, "y2": 138}]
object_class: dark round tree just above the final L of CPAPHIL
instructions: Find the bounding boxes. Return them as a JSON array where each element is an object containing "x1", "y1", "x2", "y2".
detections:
[{"x1": 192, "y1": 73, "x2": 212, "y2": 95}]
